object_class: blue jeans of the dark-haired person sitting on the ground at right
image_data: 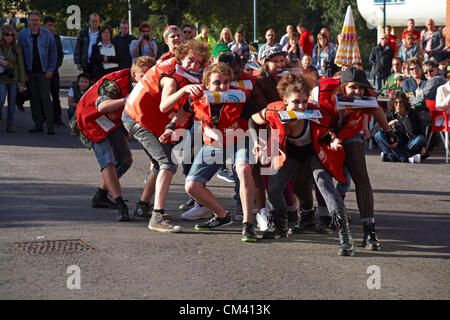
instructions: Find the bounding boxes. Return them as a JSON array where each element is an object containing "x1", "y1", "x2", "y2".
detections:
[{"x1": 374, "y1": 131, "x2": 426, "y2": 162}]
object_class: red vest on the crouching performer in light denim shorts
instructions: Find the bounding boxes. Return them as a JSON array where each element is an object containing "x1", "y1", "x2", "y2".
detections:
[{"x1": 191, "y1": 96, "x2": 248, "y2": 147}]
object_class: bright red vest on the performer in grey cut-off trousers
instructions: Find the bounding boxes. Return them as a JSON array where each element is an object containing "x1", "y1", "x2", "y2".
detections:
[{"x1": 124, "y1": 58, "x2": 190, "y2": 142}]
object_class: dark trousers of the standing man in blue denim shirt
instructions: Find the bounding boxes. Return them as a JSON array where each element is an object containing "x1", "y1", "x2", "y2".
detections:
[{"x1": 28, "y1": 73, "x2": 55, "y2": 132}]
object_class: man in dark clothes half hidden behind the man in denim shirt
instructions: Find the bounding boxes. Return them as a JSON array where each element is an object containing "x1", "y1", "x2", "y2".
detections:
[{"x1": 42, "y1": 17, "x2": 66, "y2": 128}]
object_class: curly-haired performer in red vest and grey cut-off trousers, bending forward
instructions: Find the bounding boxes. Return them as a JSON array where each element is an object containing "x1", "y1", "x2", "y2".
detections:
[{"x1": 122, "y1": 40, "x2": 209, "y2": 232}]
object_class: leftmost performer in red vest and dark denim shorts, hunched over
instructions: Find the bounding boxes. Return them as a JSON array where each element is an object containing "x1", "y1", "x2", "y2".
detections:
[{"x1": 76, "y1": 57, "x2": 155, "y2": 221}]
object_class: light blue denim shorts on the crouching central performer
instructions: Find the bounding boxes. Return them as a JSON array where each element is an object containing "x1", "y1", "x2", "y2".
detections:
[{"x1": 186, "y1": 143, "x2": 250, "y2": 184}]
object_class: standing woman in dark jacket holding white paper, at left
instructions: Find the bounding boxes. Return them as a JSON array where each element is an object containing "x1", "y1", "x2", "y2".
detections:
[{"x1": 91, "y1": 26, "x2": 120, "y2": 81}]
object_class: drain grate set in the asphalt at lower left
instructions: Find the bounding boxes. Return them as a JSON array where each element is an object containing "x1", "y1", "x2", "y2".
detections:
[{"x1": 13, "y1": 239, "x2": 95, "y2": 254}]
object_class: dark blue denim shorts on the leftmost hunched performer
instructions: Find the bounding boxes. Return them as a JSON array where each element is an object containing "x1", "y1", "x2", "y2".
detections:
[{"x1": 92, "y1": 125, "x2": 131, "y2": 170}]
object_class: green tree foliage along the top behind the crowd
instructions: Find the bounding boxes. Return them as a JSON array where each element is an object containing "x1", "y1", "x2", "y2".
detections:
[{"x1": 0, "y1": 0, "x2": 376, "y2": 67}]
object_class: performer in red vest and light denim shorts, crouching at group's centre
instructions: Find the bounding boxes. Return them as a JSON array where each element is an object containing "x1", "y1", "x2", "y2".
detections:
[{"x1": 162, "y1": 62, "x2": 257, "y2": 242}]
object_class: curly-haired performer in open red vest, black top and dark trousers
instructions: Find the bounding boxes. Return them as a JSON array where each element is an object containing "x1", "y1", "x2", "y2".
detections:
[{"x1": 250, "y1": 74, "x2": 354, "y2": 256}]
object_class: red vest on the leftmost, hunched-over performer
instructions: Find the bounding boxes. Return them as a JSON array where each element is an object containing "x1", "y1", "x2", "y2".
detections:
[{"x1": 76, "y1": 68, "x2": 131, "y2": 142}]
